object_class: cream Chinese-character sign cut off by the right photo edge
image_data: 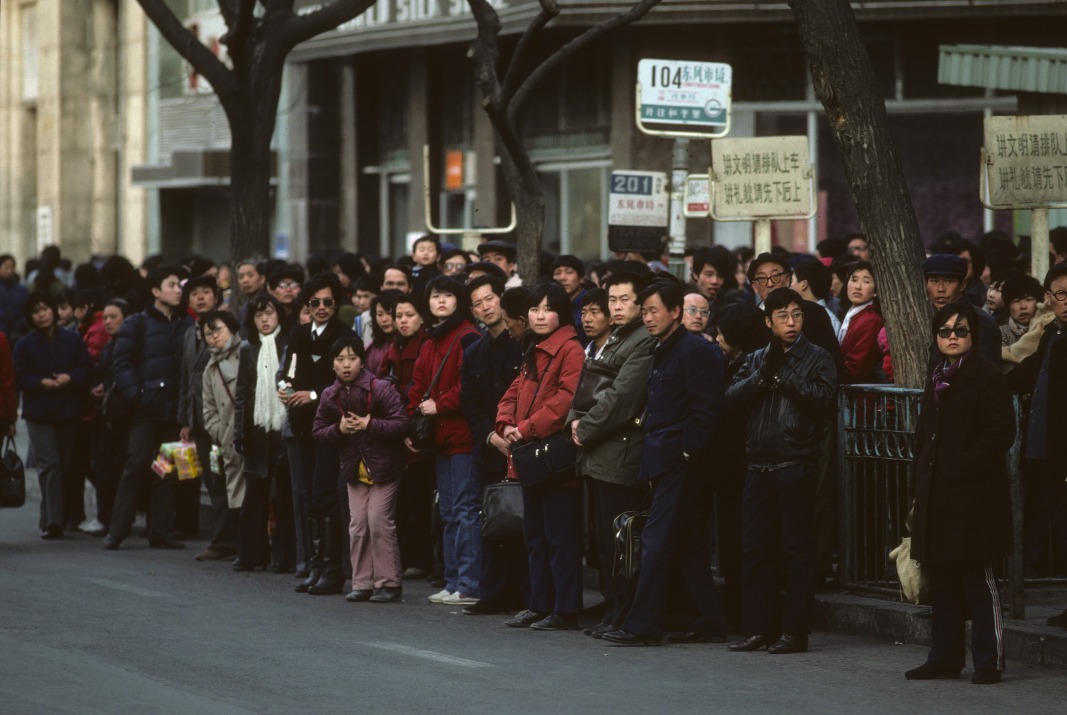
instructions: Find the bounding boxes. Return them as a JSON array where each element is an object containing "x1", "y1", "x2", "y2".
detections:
[{"x1": 983, "y1": 115, "x2": 1067, "y2": 208}]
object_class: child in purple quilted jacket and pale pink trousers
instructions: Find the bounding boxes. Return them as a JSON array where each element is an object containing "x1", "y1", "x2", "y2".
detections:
[{"x1": 312, "y1": 335, "x2": 408, "y2": 603}]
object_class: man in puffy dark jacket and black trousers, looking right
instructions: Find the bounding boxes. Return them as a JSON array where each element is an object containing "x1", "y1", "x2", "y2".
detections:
[{"x1": 103, "y1": 266, "x2": 193, "y2": 551}]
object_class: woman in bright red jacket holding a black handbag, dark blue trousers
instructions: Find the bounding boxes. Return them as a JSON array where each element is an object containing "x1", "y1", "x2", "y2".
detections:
[{"x1": 496, "y1": 283, "x2": 585, "y2": 631}]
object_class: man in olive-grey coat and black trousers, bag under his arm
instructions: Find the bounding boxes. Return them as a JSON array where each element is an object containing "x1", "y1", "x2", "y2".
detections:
[{"x1": 567, "y1": 272, "x2": 655, "y2": 638}]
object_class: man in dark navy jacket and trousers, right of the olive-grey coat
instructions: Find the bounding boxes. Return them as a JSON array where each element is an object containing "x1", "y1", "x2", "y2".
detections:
[{"x1": 604, "y1": 280, "x2": 727, "y2": 646}]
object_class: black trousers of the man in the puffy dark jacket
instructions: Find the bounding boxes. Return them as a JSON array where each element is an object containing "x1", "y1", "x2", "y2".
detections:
[{"x1": 109, "y1": 419, "x2": 178, "y2": 541}]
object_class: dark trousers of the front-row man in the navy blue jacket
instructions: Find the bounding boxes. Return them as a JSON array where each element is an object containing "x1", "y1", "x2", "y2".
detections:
[{"x1": 622, "y1": 465, "x2": 727, "y2": 638}]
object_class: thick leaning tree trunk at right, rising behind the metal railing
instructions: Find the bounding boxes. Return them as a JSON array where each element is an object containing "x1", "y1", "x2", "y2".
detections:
[{"x1": 790, "y1": 0, "x2": 931, "y2": 387}]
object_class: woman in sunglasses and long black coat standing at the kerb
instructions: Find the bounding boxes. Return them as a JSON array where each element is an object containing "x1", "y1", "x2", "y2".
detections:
[{"x1": 904, "y1": 300, "x2": 1015, "y2": 684}]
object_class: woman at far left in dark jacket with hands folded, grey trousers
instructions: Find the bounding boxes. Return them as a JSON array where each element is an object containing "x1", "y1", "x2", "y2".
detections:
[{"x1": 14, "y1": 292, "x2": 92, "y2": 539}]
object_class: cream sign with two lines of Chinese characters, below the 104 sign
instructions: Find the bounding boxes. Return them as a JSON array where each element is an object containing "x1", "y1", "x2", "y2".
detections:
[{"x1": 712, "y1": 137, "x2": 812, "y2": 219}]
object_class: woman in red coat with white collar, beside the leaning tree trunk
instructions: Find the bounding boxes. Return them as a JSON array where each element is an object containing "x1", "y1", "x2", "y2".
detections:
[{"x1": 838, "y1": 260, "x2": 883, "y2": 384}]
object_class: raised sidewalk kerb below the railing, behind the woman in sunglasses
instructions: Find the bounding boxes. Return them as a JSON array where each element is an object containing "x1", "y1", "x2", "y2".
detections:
[{"x1": 815, "y1": 587, "x2": 1067, "y2": 668}]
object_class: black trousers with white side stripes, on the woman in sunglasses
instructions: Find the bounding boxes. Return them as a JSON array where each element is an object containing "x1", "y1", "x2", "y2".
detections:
[{"x1": 923, "y1": 561, "x2": 1004, "y2": 670}]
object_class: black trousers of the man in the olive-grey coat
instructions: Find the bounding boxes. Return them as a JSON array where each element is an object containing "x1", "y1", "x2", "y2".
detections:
[{"x1": 586, "y1": 479, "x2": 648, "y2": 623}]
